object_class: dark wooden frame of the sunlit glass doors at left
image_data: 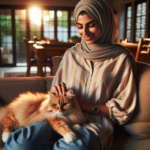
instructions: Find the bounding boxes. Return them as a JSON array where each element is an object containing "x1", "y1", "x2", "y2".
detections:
[{"x1": 0, "y1": 5, "x2": 74, "y2": 67}]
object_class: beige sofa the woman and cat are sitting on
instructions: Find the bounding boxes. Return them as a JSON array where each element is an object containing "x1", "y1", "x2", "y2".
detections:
[{"x1": 0, "y1": 62, "x2": 150, "y2": 150}]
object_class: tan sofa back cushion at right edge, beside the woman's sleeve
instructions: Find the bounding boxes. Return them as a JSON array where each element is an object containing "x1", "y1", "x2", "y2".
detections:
[{"x1": 132, "y1": 67, "x2": 150, "y2": 122}]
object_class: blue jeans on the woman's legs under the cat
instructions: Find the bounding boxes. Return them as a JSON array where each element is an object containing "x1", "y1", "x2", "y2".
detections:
[{"x1": 5, "y1": 121, "x2": 100, "y2": 150}]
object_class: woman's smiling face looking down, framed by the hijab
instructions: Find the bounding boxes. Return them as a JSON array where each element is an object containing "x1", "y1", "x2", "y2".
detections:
[{"x1": 76, "y1": 14, "x2": 101, "y2": 45}]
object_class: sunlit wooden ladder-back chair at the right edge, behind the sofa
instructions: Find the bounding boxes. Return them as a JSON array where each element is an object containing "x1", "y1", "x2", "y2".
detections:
[{"x1": 135, "y1": 38, "x2": 150, "y2": 63}]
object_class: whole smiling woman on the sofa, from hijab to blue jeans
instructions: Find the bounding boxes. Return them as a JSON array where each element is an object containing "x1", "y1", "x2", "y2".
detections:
[{"x1": 5, "y1": 0, "x2": 136, "y2": 150}]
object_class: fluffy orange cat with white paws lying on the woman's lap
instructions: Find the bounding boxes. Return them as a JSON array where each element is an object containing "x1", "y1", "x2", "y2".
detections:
[{"x1": 0, "y1": 90, "x2": 87, "y2": 143}]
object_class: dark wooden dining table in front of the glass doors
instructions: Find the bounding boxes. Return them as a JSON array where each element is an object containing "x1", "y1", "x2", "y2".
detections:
[{"x1": 28, "y1": 41, "x2": 74, "y2": 76}]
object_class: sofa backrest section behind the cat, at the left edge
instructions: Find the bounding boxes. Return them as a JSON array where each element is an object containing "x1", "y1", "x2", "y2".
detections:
[{"x1": 0, "y1": 77, "x2": 47, "y2": 105}]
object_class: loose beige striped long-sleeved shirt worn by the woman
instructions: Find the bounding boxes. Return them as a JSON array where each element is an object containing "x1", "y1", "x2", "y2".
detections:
[{"x1": 51, "y1": 49, "x2": 137, "y2": 150}]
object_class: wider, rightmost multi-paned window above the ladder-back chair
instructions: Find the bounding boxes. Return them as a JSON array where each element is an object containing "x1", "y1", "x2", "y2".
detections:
[{"x1": 135, "y1": 2, "x2": 146, "y2": 42}]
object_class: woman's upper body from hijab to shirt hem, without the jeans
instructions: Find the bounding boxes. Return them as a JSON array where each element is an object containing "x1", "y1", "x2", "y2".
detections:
[{"x1": 52, "y1": 0, "x2": 136, "y2": 150}]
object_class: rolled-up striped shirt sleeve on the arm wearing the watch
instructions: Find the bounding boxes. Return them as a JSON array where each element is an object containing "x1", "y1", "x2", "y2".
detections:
[{"x1": 106, "y1": 55, "x2": 137, "y2": 124}]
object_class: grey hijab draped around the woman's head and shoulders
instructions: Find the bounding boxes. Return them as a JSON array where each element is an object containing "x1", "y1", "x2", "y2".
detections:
[{"x1": 73, "y1": 0, "x2": 136, "y2": 81}]
